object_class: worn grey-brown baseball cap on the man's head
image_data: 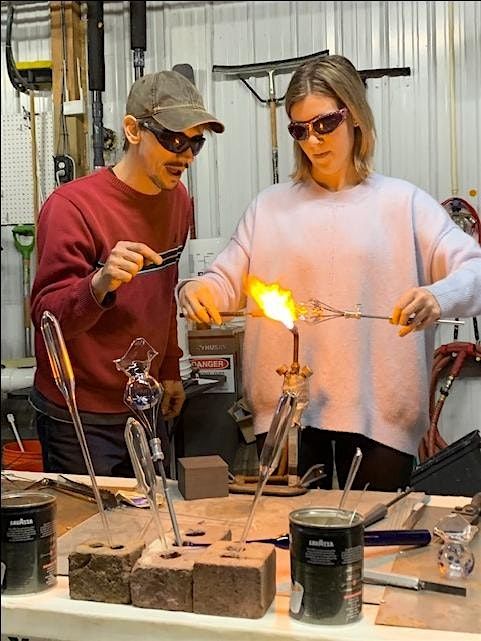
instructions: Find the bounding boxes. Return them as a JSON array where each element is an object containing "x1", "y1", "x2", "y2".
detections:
[{"x1": 126, "y1": 71, "x2": 225, "y2": 134}]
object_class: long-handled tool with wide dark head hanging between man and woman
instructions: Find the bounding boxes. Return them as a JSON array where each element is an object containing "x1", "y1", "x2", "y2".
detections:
[{"x1": 212, "y1": 50, "x2": 329, "y2": 183}]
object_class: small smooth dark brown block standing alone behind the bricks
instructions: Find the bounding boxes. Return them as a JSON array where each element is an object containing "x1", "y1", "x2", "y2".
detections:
[{"x1": 178, "y1": 455, "x2": 229, "y2": 500}]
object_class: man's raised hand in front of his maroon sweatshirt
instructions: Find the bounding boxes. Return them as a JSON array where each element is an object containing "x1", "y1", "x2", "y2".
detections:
[{"x1": 92, "y1": 240, "x2": 162, "y2": 303}]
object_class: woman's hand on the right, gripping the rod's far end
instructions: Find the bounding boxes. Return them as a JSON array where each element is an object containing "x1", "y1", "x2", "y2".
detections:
[{"x1": 391, "y1": 287, "x2": 441, "y2": 336}]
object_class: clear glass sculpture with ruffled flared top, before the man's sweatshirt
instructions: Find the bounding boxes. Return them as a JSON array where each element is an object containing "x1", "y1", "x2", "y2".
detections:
[{"x1": 114, "y1": 338, "x2": 164, "y2": 439}]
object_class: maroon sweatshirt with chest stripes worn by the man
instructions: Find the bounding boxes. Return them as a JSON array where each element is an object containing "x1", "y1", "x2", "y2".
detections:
[{"x1": 31, "y1": 168, "x2": 191, "y2": 414}]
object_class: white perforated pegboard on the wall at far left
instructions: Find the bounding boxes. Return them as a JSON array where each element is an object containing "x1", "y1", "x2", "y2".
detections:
[{"x1": 1, "y1": 112, "x2": 55, "y2": 225}]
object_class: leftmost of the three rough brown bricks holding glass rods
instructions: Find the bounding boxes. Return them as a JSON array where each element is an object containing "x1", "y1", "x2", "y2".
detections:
[{"x1": 68, "y1": 541, "x2": 144, "y2": 603}]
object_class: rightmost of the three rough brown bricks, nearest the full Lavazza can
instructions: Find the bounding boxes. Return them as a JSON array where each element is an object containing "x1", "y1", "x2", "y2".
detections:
[{"x1": 194, "y1": 541, "x2": 276, "y2": 619}]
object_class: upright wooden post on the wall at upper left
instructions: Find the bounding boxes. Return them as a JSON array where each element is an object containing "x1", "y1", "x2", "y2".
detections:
[{"x1": 50, "y1": 2, "x2": 90, "y2": 177}]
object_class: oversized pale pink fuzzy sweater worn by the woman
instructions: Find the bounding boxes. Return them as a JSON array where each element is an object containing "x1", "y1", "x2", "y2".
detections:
[{"x1": 185, "y1": 174, "x2": 481, "y2": 454}]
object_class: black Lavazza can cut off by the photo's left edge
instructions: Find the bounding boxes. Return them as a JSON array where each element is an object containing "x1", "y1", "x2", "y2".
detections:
[{"x1": 1, "y1": 492, "x2": 57, "y2": 594}]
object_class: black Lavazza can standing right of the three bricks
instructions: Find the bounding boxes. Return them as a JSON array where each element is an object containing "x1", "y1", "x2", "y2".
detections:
[{"x1": 289, "y1": 507, "x2": 364, "y2": 625}]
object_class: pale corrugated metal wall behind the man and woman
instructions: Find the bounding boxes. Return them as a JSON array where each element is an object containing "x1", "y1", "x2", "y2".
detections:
[{"x1": 1, "y1": 1, "x2": 481, "y2": 440}]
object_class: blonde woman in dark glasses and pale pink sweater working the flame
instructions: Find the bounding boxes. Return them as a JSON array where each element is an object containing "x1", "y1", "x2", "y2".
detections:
[{"x1": 179, "y1": 55, "x2": 481, "y2": 491}]
